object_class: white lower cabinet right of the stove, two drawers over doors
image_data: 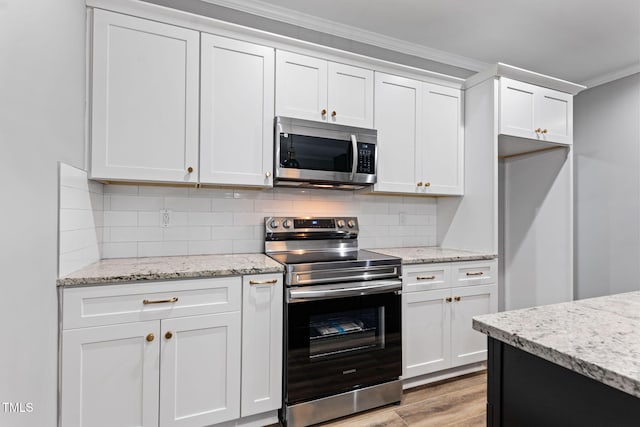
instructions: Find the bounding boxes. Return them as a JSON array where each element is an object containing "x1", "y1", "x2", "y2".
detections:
[{"x1": 402, "y1": 261, "x2": 498, "y2": 379}]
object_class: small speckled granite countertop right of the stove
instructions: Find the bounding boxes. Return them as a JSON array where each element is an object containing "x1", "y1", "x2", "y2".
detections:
[{"x1": 371, "y1": 246, "x2": 498, "y2": 264}]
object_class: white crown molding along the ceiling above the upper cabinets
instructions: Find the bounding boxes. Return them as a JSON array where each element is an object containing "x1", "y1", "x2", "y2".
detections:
[{"x1": 202, "y1": 0, "x2": 490, "y2": 72}]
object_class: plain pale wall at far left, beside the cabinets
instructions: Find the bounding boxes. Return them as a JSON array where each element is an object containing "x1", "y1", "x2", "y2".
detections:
[{"x1": 0, "y1": 0, "x2": 85, "y2": 427}]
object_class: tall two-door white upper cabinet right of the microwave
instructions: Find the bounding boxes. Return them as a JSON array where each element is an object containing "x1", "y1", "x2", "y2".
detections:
[{"x1": 374, "y1": 73, "x2": 464, "y2": 195}]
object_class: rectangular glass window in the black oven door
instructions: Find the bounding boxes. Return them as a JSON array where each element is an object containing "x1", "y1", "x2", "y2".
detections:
[{"x1": 309, "y1": 306, "x2": 384, "y2": 359}]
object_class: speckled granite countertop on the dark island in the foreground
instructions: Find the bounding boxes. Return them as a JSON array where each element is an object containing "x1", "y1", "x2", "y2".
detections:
[{"x1": 473, "y1": 292, "x2": 640, "y2": 397}]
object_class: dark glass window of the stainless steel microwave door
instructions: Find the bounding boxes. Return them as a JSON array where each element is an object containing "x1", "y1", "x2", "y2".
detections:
[{"x1": 280, "y1": 133, "x2": 353, "y2": 173}]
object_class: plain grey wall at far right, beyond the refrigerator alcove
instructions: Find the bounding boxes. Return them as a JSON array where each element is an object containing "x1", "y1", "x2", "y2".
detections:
[{"x1": 574, "y1": 74, "x2": 640, "y2": 299}]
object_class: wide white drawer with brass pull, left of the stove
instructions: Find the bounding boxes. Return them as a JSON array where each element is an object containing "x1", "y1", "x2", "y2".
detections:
[{"x1": 62, "y1": 277, "x2": 242, "y2": 329}]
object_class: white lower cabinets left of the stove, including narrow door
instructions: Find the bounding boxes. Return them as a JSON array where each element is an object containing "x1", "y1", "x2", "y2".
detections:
[{"x1": 60, "y1": 274, "x2": 282, "y2": 427}]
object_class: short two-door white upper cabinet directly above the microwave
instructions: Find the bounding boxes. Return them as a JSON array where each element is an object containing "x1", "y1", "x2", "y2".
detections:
[{"x1": 276, "y1": 50, "x2": 373, "y2": 128}]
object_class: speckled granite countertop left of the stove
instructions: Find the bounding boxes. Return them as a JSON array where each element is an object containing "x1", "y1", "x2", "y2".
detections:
[{"x1": 58, "y1": 254, "x2": 284, "y2": 286}]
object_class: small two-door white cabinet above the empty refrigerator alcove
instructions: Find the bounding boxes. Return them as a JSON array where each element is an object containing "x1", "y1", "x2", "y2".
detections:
[{"x1": 500, "y1": 77, "x2": 573, "y2": 144}]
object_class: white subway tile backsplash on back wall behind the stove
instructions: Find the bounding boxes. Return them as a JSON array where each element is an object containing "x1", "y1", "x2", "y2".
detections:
[{"x1": 102, "y1": 184, "x2": 436, "y2": 258}]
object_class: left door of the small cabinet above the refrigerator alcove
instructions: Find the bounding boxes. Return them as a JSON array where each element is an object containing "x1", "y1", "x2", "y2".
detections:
[{"x1": 500, "y1": 77, "x2": 540, "y2": 139}]
